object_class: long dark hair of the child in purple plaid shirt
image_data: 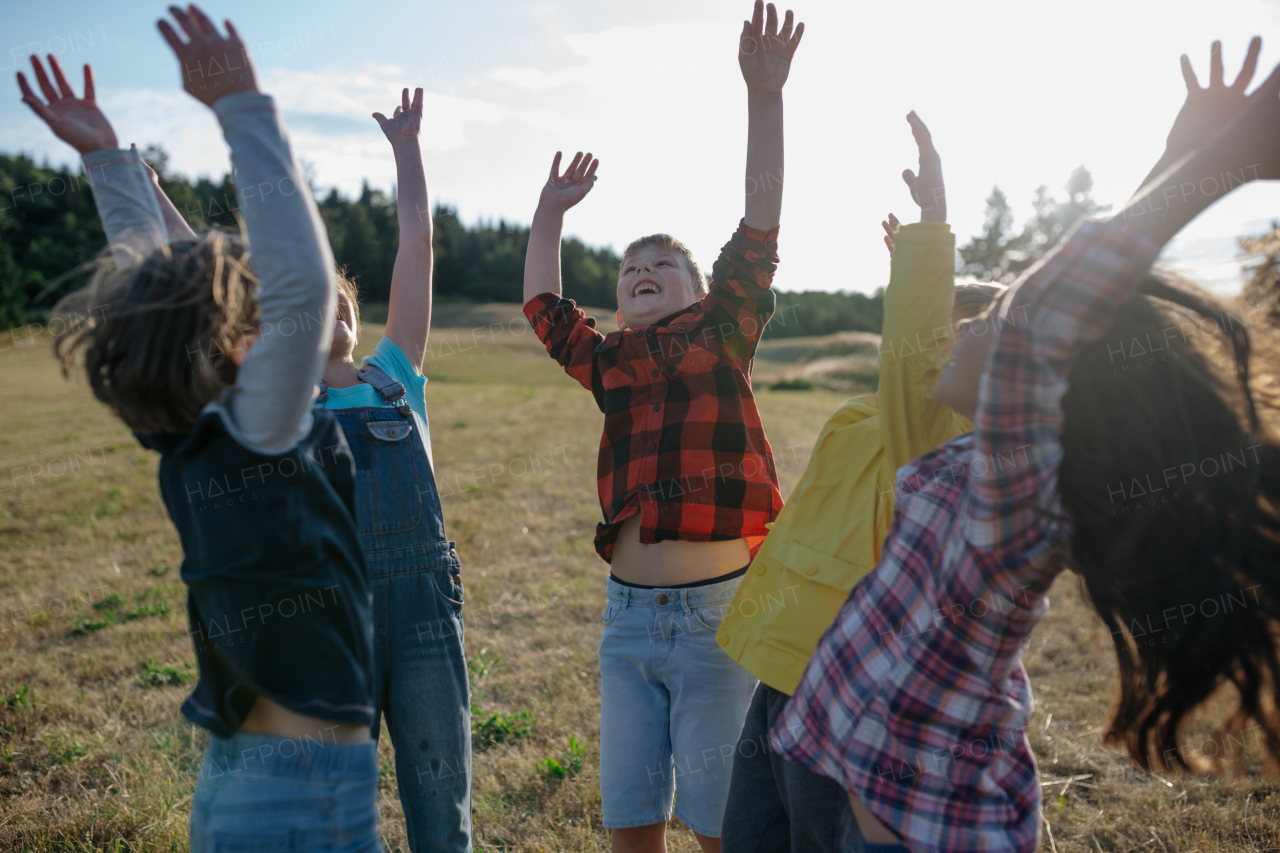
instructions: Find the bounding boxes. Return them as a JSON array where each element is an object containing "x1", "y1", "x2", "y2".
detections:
[{"x1": 1059, "y1": 278, "x2": 1280, "y2": 768}]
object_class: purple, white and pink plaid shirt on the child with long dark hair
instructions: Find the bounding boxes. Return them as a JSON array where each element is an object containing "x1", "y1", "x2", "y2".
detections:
[{"x1": 771, "y1": 223, "x2": 1157, "y2": 853}]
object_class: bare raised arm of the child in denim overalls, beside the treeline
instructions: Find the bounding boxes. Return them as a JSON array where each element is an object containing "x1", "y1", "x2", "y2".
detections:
[{"x1": 374, "y1": 88, "x2": 431, "y2": 369}]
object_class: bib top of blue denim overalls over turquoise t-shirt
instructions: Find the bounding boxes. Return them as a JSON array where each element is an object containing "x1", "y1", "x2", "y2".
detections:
[{"x1": 316, "y1": 364, "x2": 462, "y2": 578}]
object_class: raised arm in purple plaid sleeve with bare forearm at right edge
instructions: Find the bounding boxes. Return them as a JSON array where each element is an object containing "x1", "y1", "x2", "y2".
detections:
[{"x1": 965, "y1": 43, "x2": 1280, "y2": 549}]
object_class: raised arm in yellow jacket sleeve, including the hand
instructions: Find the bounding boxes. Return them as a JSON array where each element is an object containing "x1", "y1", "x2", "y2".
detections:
[{"x1": 879, "y1": 111, "x2": 956, "y2": 470}]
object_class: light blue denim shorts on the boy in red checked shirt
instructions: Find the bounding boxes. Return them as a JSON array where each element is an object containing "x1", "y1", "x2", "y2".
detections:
[{"x1": 600, "y1": 578, "x2": 755, "y2": 838}]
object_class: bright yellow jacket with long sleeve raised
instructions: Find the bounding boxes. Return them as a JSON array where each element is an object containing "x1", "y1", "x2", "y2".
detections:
[{"x1": 717, "y1": 223, "x2": 973, "y2": 693}]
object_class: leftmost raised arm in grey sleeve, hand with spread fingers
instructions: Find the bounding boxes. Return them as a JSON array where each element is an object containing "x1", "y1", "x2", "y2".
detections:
[{"x1": 18, "y1": 55, "x2": 170, "y2": 262}]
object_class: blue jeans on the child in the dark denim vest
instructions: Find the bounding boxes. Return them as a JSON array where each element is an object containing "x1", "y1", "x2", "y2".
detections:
[{"x1": 191, "y1": 733, "x2": 383, "y2": 853}]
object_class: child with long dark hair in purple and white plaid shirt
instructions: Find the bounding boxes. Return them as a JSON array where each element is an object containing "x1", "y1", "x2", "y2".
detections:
[{"x1": 772, "y1": 41, "x2": 1280, "y2": 853}]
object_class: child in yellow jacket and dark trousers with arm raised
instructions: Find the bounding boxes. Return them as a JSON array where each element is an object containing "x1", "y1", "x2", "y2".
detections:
[{"x1": 718, "y1": 113, "x2": 1004, "y2": 853}]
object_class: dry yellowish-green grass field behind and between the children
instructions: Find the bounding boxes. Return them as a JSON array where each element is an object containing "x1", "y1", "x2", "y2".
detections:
[{"x1": 0, "y1": 306, "x2": 1280, "y2": 853}]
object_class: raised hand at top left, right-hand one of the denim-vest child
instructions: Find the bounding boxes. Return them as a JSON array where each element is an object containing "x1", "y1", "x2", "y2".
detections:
[{"x1": 156, "y1": 4, "x2": 257, "y2": 106}]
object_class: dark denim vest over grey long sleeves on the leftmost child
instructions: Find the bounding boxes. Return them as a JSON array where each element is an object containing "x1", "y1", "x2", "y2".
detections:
[{"x1": 137, "y1": 411, "x2": 374, "y2": 738}]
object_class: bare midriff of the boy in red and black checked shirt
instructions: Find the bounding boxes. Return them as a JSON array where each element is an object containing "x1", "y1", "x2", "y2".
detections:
[{"x1": 611, "y1": 515, "x2": 751, "y2": 587}]
